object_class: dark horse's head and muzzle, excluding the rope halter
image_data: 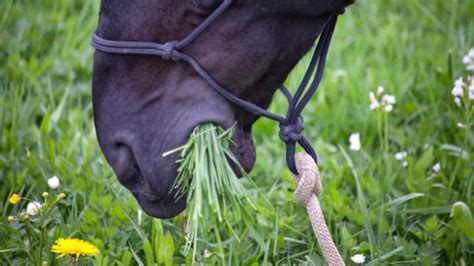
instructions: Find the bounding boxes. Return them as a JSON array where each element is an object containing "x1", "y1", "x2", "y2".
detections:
[{"x1": 93, "y1": 0, "x2": 353, "y2": 218}]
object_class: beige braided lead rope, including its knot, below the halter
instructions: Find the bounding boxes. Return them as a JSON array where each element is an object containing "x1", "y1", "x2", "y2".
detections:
[{"x1": 293, "y1": 153, "x2": 345, "y2": 266}]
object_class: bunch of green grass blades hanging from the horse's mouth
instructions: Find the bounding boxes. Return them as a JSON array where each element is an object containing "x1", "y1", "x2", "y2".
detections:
[{"x1": 168, "y1": 123, "x2": 256, "y2": 261}]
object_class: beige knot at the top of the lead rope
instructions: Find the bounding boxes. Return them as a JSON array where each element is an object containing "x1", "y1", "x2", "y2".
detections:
[{"x1": 293, "y1": 153, "x2": 322, "y2": 206}]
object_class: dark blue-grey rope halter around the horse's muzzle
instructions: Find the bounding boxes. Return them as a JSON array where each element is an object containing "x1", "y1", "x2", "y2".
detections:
[{"x1": 91, "y1": 0, "x2": 338, "y2": 174}]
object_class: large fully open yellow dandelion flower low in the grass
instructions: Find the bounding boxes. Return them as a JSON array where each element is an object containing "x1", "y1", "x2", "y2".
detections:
[{"x1": 51, "y1": 238, "x2": 100, "y2": 260}]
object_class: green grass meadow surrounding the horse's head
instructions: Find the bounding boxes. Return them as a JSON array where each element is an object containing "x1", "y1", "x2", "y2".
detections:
[{"x1": 0, "y1": 0, "x2": 474, "y2": 265}]
